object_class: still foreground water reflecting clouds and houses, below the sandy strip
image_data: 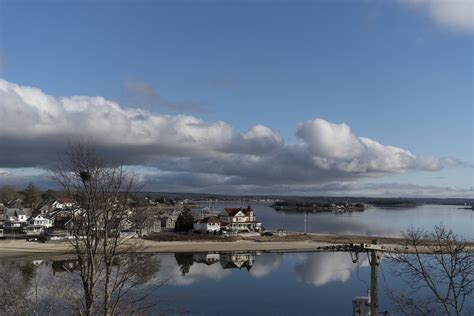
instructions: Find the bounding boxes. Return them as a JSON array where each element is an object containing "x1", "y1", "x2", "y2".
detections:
[{"x1": 0, "y1": 252, "x2": 474, "y2": 315}]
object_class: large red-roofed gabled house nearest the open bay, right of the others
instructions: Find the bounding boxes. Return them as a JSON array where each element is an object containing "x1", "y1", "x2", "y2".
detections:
[{"x1": 219, "y1": 205, "x2": 262, "y2": 232}]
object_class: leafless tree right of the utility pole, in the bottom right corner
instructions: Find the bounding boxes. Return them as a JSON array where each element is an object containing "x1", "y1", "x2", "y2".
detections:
[{"x1": 390, "y1": 225, "x2": 474, "y2": 315}]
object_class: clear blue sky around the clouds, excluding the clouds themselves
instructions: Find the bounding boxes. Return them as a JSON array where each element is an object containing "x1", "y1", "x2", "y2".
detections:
[{"x1": 0, "y1": 0, "x2": 474, "y2": 196}]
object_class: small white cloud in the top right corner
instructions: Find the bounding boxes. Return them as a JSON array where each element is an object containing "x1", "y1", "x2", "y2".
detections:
[{"x1": 402, "y1": 0, "x2": 474, "y2": 32}]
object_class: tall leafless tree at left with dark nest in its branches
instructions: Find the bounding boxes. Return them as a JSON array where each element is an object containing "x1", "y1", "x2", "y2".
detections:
[{"x1": 53, "y1": 142, "x2": 150, "y2": 315}]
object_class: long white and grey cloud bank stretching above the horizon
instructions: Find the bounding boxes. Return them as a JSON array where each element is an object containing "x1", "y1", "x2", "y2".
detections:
[{"x1": 0, "y1": 80, "x2": 458, "y2": 190}]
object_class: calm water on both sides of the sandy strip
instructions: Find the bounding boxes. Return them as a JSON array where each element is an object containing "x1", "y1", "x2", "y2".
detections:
[{"x1": 0, "y1": 203, "x2": 474, "y2": 315}]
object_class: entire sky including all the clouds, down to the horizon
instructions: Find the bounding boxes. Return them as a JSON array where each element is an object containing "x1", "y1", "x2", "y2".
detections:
[{"x1": 0, "y1": 0, "x2": 474, "y2": 197}]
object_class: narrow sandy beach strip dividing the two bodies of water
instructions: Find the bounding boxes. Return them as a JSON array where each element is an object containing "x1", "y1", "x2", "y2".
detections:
[{"x1": 0, "y1": 234, "x2": 474, "y2": 260}]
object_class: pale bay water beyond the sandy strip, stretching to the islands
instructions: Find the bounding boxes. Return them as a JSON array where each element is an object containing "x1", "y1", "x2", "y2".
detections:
[{"x1": 199, "y1": 202, "x2": 474, "y2": 240}]
